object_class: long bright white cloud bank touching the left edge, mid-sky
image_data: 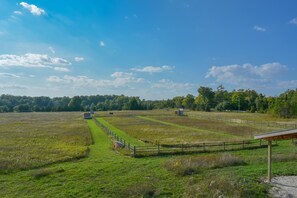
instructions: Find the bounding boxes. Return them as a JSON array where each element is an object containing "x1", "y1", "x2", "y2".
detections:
[{"x1": 0, "y1": 53, "x2": 71, "y2": 68}]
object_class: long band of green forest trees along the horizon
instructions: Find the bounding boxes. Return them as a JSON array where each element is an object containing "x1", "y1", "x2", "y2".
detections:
[{"x1": 0, "y1": 85, "x2": 297, "y2": 118}]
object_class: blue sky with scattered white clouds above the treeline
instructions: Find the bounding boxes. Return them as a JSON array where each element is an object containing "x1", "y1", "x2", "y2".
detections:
[{"x1": 0, "y1": 0, "x2": 297, "y2": 99}]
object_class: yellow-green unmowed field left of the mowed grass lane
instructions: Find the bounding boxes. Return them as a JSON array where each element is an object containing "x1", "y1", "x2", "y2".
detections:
[{"x1": 0, "y1": 113, "x2": 92, "y2": 172}]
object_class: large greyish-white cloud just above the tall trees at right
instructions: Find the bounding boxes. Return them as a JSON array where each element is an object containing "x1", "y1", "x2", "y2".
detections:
[{"x1": 205, "y1": 63, "x2": 288, "y2": 88}]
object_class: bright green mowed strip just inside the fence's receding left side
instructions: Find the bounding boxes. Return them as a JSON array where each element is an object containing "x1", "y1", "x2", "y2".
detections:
[{"x1": 95, "y1": 117, "x2": 146, "y2": 146}]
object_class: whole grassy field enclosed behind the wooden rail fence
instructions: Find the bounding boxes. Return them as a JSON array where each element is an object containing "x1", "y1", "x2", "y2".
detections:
[{"x1": 98, "y1": 110, "x2": 294, "y2": 144}]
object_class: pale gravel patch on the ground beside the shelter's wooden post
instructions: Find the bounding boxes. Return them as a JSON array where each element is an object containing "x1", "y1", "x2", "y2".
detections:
[{"x1": 270, "y1": 176, "x2": 297, "y2": 198}]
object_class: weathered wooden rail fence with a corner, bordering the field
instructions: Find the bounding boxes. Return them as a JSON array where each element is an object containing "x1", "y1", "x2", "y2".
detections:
[{"x1": 94, "y1": 118, "x2": 277, "y2": 157}]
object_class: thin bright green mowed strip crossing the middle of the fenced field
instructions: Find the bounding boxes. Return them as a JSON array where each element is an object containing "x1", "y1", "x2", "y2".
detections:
[{"x1": 137, "y1": 116, "x2": 238, "y2": 138}]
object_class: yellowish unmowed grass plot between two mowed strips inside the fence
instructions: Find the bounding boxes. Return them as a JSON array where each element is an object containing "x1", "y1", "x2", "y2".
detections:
[{"x1": 104, "y1": 115, "x2": 236, "y2": 144}]
